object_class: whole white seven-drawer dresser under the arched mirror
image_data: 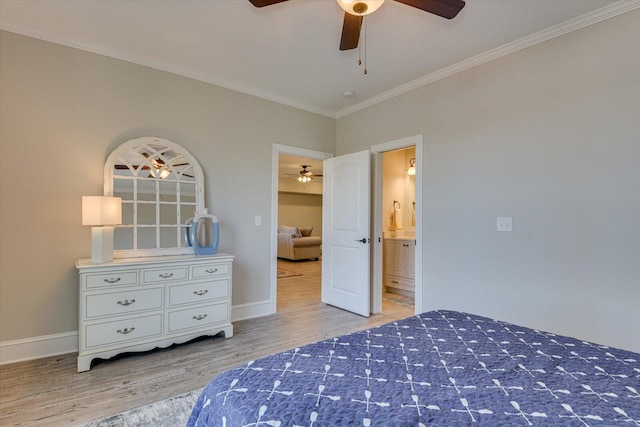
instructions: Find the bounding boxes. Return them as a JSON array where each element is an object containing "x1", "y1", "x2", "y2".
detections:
[{"x1": 76, "y1": 254, "x2": 234, "y2": 372}]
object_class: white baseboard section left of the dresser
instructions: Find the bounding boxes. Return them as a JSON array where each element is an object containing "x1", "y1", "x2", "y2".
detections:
[{"x1": 0, "y1": 331, "x2": 78, "y2": 365}]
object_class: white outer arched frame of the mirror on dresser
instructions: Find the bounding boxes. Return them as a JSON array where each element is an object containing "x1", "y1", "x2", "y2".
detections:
[{"x1": 104, "y1": 136, "x2": 205, "y2": 259}]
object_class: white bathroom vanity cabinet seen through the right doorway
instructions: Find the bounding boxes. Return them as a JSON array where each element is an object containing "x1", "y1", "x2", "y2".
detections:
[{"x1": 383, "y1": 237, "x2": 416, "y2": 295}]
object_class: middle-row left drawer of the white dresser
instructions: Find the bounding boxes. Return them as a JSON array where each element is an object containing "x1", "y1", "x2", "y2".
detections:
[{"x1": 85, "y1": 288, "x2": 162, "y2": 318}]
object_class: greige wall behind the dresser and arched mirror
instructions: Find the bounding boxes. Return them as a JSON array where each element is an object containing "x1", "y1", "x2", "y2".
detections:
[{"x1": 0, "y1": 32, "x2": 336, "y2": 341}]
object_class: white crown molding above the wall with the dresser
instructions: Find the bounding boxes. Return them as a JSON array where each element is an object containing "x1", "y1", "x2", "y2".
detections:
[{"x1": 0, "y1": 20, "x2": 336, "y2": 119}]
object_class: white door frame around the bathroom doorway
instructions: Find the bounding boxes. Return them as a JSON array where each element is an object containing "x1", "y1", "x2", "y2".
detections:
[{"x1": 370, "y1": 135, "x2": 423, "y2": 314}]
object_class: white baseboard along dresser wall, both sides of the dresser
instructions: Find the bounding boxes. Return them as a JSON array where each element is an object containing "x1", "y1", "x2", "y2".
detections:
[{"x1": 0, "y1": 301, "x2": 273, "y2": 365}]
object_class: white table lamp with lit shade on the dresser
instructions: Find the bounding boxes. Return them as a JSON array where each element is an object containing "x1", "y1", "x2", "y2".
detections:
[{"x1": 82, "y1": 196, "x2": 122, "y2": 263}]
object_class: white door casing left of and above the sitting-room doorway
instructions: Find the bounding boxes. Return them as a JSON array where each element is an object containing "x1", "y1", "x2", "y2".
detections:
[{"x1": 269, "y1": 144, "x2": 333, "y2": 313}]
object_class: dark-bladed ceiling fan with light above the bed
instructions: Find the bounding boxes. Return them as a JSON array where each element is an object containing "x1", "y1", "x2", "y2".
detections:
[{"x1": 249, "y1": 0, "x2": 465, "y2": 50}]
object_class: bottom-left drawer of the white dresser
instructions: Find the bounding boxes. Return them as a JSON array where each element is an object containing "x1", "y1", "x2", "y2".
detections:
[{"x1": 85, "y1": 314, "x2": 162, "y2": 347}]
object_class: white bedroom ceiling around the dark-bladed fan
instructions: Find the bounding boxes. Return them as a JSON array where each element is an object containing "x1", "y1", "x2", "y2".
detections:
[{"x1": 0, "y1": 0, "x2": 640, "y2": 118}]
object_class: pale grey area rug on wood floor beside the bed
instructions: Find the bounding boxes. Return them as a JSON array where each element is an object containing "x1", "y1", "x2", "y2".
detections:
[{"x1": 78, "y1": 389, "x2": 202, "y2": 427}]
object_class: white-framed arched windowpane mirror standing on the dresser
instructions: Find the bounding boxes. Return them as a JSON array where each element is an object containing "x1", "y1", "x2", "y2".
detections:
[{"x1": 104, "y1": 137, "x2": 204, "y2": 258}]
